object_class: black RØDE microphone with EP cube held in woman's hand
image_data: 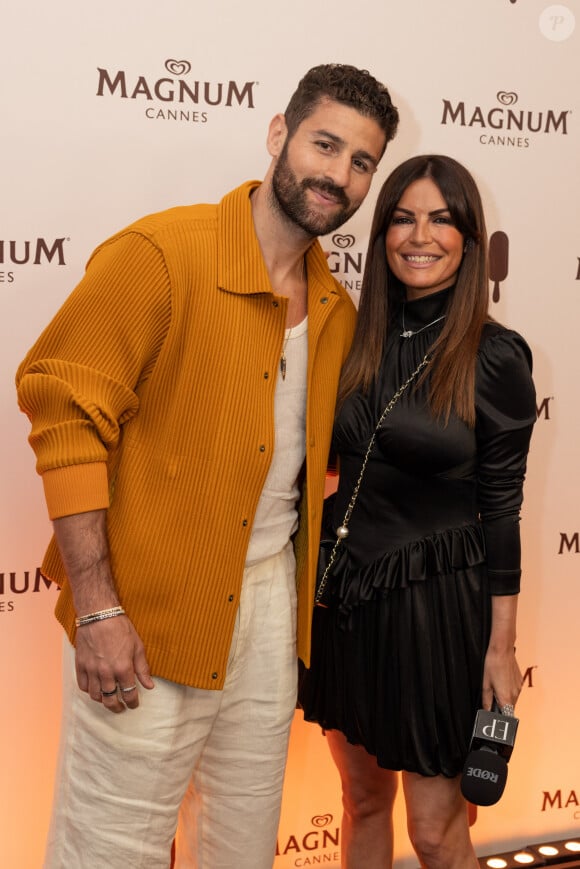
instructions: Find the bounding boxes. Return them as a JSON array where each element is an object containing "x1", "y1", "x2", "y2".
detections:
[{"x1": 461, "y1": 701, "x2": 519, "y2": 806}]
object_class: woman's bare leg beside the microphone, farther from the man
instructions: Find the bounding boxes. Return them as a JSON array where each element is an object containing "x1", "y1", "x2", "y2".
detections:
[{"x1": 403, "y1": 772, "x2": 479, "y2": 869}]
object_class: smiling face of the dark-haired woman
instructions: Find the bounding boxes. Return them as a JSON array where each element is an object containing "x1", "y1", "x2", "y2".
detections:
[{"x1": 385, "y1": 178, "x2": 464, "y2": 299}]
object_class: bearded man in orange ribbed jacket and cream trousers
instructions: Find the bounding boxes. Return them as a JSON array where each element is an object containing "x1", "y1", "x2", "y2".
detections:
[{"x1": 17, "y1": 64, "x2": 398, "y2": 869}]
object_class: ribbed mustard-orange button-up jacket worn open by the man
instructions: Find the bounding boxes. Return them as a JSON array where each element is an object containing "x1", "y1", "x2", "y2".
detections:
[{"x1": 17, "y1": 182, "x2": 355, "y2": 688}]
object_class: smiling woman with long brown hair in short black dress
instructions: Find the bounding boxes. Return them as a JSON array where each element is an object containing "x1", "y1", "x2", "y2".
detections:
[{"x1": 301, "y1": 156, "x2": 536, "y2": 869}]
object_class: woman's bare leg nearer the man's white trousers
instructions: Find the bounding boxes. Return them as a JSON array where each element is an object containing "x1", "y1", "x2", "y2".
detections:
[{"x1": 326, "y1": 730, "x2": 397, "y2": 869}]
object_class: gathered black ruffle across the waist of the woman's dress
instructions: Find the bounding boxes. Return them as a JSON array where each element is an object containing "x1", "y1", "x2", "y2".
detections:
[{"x1": 329, "y1": 525, "x2": 485, "y2": 628}]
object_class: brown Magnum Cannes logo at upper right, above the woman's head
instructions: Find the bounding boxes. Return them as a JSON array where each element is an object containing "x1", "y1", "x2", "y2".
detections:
[{"x1": 441, "y1": 91, "x2": 570, "y2": 148}]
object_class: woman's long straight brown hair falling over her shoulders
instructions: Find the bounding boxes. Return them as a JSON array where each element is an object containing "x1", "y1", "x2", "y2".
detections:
[{"x1": 338, "y1": 154, "x2": 489, "y2": 427}]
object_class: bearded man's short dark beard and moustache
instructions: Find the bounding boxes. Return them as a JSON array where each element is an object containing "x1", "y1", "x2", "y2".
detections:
[{"x1": 272, "y1": 145, "x2": 360, "y2": 237}]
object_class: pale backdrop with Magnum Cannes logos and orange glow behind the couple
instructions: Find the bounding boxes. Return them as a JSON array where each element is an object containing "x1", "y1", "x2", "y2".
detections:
[{"x1": 0, "y1": 0, "x2": 580, "y2": 869}]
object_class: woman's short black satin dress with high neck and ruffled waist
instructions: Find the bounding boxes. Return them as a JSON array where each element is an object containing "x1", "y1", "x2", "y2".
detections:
[{"x1": 300, "y1": 290, "x2": 536, "y2": 776}]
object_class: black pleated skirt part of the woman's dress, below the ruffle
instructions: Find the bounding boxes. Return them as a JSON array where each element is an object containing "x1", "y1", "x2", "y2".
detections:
[{"x1": 299, "y1": 557, "x2": 490, "y2": 777}]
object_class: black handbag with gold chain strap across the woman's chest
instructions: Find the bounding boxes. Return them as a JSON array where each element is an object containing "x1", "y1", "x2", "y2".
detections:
[{"x1": 314, "y1": 354, "x2": 429, "y2": 607}]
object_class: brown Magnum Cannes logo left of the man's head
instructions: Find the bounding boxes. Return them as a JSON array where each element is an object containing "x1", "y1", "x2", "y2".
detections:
[{"x1": 97, "y1": 58, "x2": 256, "y2": 122}]
